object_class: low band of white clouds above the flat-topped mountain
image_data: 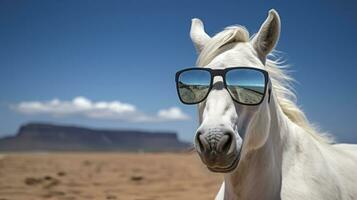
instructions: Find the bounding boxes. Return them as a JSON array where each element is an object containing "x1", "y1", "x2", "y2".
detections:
[{"x1": 11, "y1": 97, "x2": 189, "y2": 122}]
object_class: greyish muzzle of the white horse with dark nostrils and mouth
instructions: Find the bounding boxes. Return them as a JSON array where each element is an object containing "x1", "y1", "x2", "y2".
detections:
[{"x1": 195, "y1": 128, "x2": 241, "y2": 173}]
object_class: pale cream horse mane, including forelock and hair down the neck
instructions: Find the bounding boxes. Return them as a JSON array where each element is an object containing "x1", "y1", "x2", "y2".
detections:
[{"x1": 196, "y1": 25, "x2": 333, "y2": 143}]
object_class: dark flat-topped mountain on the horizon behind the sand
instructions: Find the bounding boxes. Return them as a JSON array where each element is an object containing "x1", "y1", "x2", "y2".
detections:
[{"x1": 0, "y1": 123, "x2": 190, "y2": 151}]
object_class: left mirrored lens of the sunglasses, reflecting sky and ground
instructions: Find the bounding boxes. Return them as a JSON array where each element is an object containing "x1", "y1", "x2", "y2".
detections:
[{"x1": 177, "y1": 69, "x2": 211, "y2": 104}]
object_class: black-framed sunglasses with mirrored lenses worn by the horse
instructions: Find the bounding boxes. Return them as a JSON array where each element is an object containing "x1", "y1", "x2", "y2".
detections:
[{"x1": 176, "y1": 67, "x2": 270, "y2": 105}]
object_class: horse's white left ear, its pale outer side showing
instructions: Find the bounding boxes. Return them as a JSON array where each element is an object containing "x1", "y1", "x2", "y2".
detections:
[{"x1": 190, "y1": 18, "x2": 211, "y2": 53}]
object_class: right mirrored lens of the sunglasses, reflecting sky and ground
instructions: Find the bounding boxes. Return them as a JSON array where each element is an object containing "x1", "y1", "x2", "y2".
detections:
[{"x1": 226, "y1": 69, "x2": 265, "y2": 105}]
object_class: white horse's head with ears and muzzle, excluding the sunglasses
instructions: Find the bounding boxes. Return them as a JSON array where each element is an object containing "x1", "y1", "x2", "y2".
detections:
[{"x1": 190, "y1": 10, "x2": 280, "y2": 172}]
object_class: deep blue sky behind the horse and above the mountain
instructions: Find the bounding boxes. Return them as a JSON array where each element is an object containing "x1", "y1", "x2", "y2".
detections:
[{"x1": 0, "y1": 0, "x2": 357, "y2": 142}]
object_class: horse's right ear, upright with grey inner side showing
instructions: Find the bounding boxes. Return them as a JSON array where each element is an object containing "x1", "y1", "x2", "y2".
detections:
[{"x1": 252, "y1": 9, "x2": 280, "y2": 62}]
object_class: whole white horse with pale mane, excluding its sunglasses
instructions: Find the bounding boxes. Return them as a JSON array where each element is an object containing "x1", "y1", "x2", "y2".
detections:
[{"x1": 190, "y1": 10, "x2": 357, "y2": 200}]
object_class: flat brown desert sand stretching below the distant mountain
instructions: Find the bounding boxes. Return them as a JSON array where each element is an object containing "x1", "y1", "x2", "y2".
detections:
[{"x1": 0, "y1": 153, "x2": 223, "y2": 200}]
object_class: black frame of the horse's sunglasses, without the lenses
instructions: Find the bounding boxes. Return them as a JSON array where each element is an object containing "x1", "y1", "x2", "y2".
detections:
[{"x1": 175, "y1": 67, "x2": 270, "y2": 106}]
